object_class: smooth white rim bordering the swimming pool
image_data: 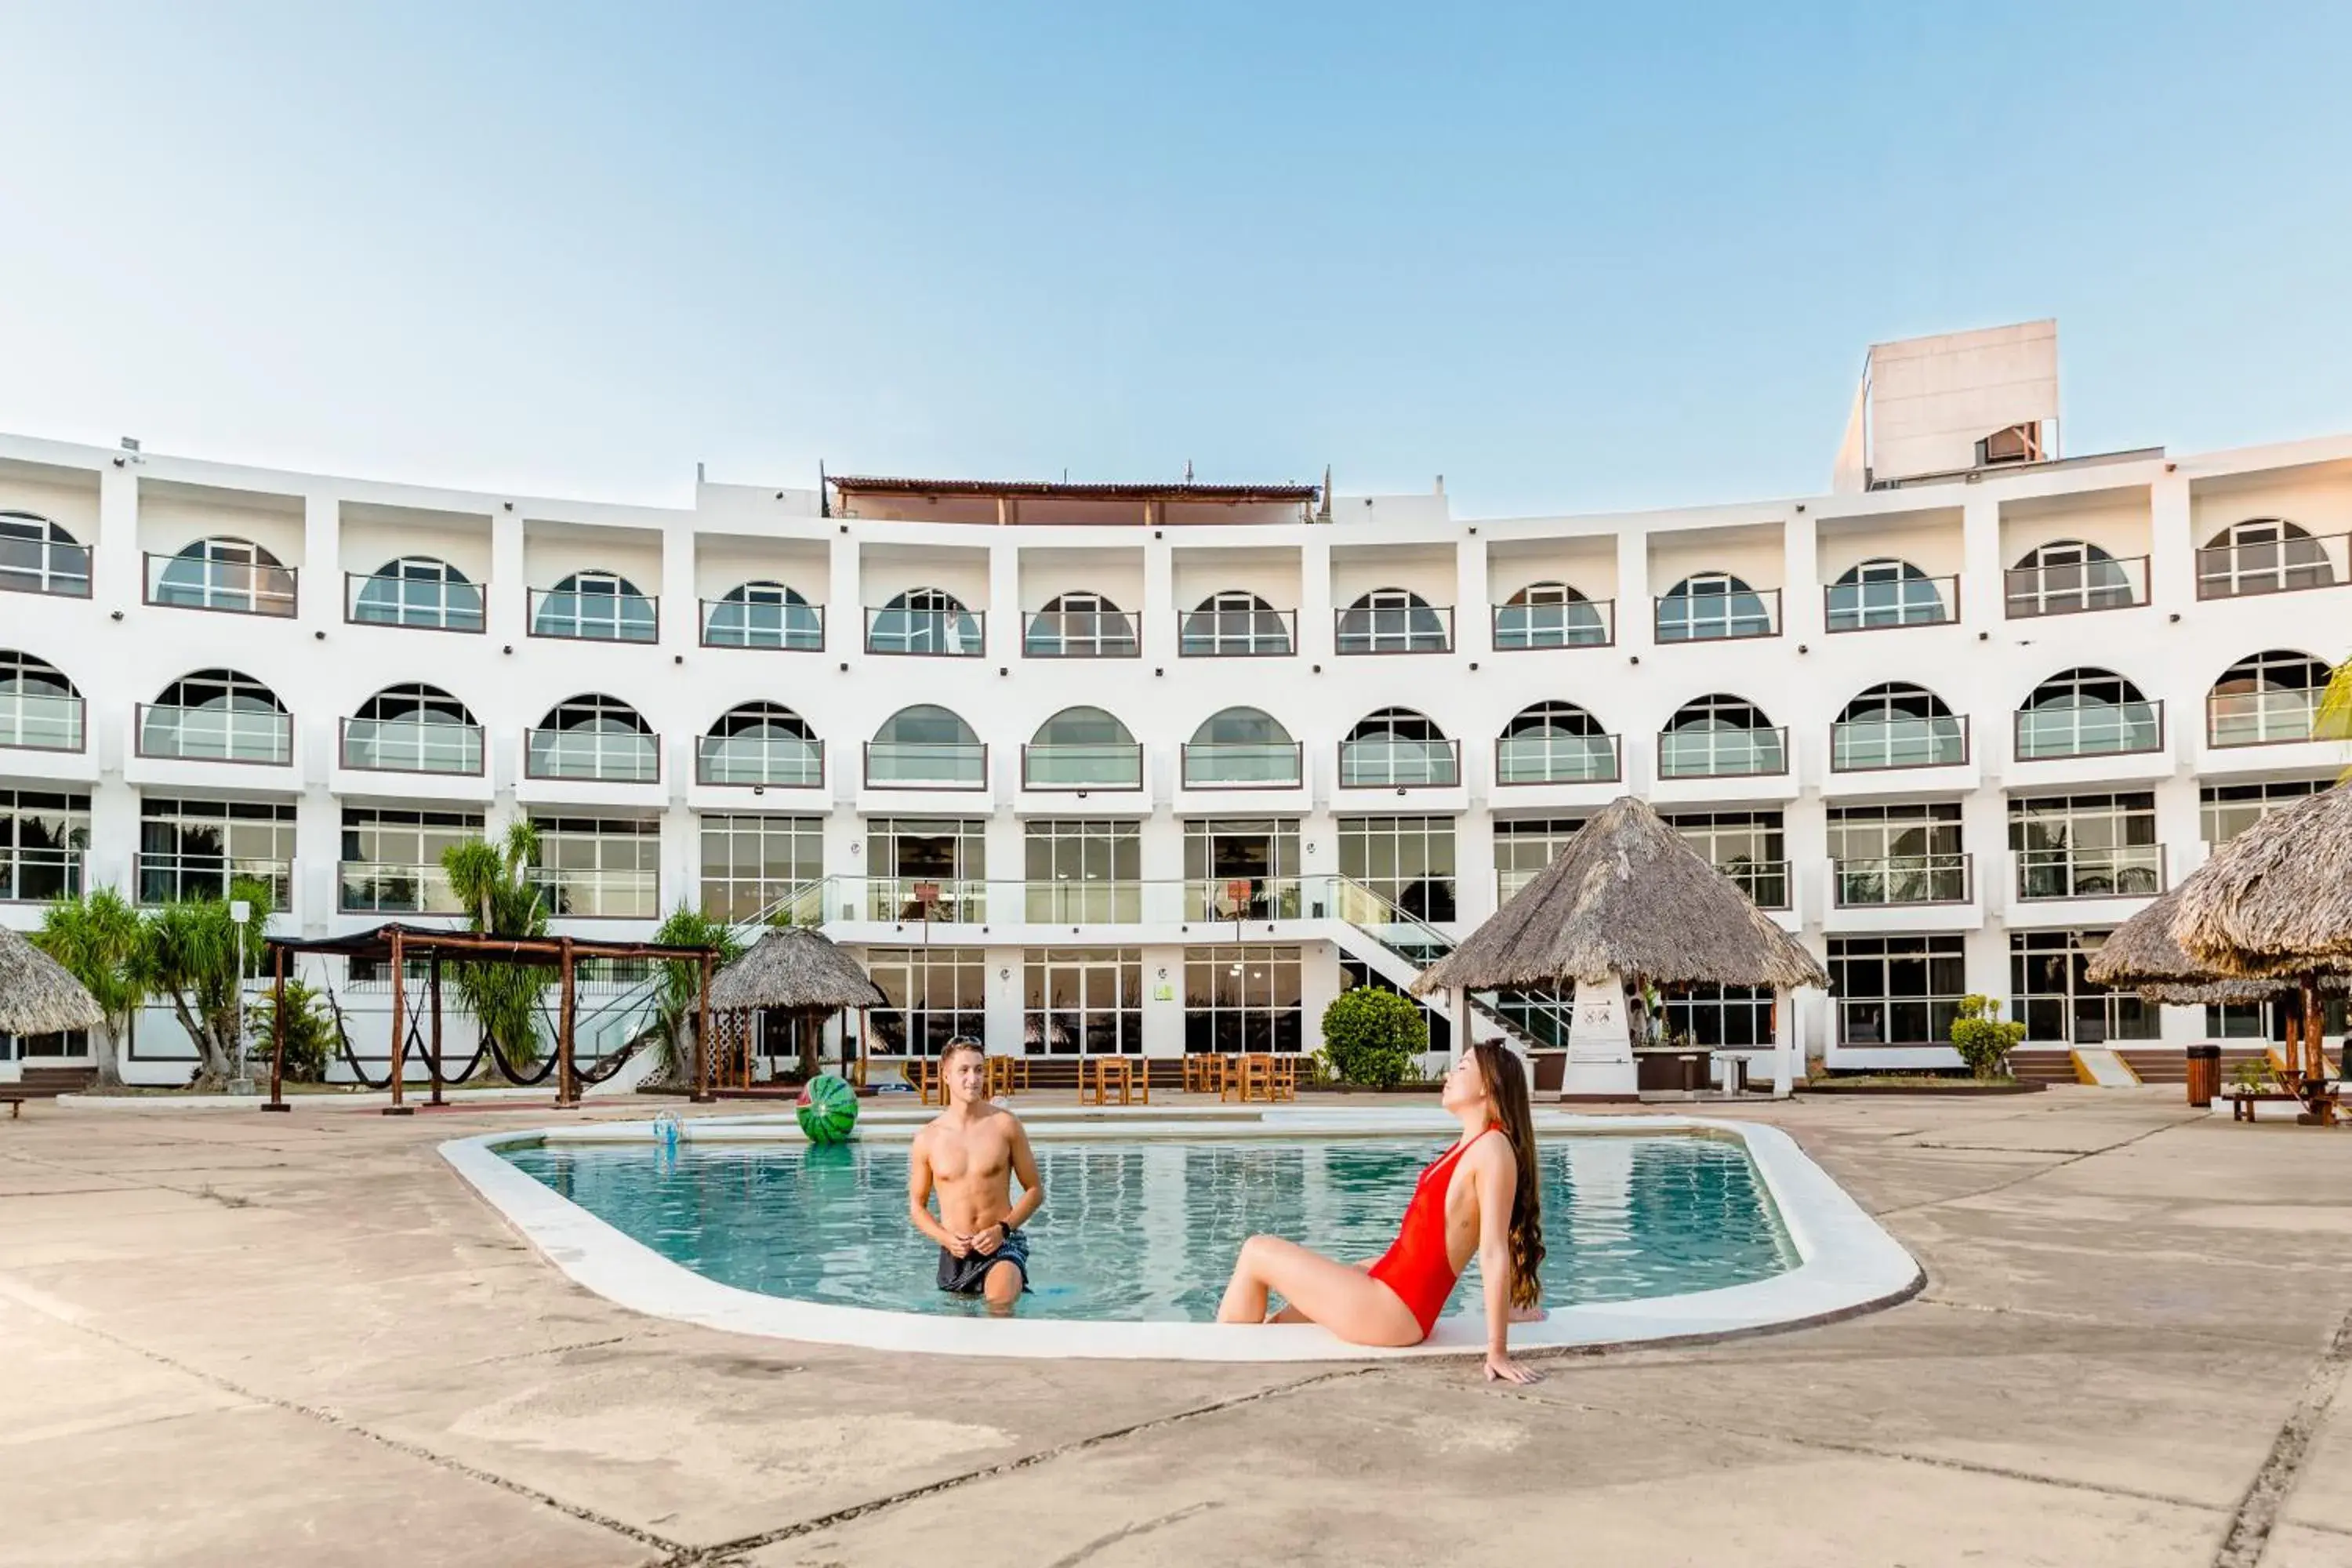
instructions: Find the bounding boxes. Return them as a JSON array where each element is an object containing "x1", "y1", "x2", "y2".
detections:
[{"x1": 440, "y1": 1112, "x2": 1922, "y2": 1361}]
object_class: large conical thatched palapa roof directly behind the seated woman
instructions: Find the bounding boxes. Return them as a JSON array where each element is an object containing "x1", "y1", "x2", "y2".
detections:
[{"x1": 1414, "y1": 794, "x2": 1830, "y2": 992}]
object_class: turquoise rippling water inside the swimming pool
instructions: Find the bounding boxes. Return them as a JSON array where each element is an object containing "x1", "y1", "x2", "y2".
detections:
[{"x1": 503, "y1": 1135, "x2": 1797, "y2": 1321}]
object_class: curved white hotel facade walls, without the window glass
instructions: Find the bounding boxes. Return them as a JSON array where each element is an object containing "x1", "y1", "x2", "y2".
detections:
[{"x1": 0, "y1": 399, "x2": 2352, "y2": 1076}]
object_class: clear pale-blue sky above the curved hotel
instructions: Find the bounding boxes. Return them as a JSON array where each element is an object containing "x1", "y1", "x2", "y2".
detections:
[{"x1": 0, "y1": 0, "x2": 2352, "y2": 513}]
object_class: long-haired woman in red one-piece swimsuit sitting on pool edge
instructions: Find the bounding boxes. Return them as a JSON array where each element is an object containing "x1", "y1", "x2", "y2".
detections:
[{"x1": 1216, "y1": 1041, "x2": 1543, "y2": 1382}]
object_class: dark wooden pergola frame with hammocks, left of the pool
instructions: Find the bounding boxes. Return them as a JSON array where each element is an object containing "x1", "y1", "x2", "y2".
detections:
[{"x1": 261, "y1": 924, "x2": 720, "y2": 1116}]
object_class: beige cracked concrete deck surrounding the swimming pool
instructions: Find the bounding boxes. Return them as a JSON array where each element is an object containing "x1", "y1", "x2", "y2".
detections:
[{"x1": 0, "y1": 1088, "x2": 2352, "y2": 1568}]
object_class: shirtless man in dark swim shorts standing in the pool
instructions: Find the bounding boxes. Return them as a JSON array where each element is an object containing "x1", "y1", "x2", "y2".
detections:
[{"x1": 906, "y1": 1039, "x2": 1044, "y2": 1314}]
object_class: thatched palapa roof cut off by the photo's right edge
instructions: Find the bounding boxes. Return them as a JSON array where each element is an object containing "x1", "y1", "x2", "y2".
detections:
[{"x1": 2171, "y1": 785, "x2": 2352, "y2": 980}]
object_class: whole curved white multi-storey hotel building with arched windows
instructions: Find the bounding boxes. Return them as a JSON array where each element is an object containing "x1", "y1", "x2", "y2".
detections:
[{"x1": 0, "y1": 322, "x2": 2352, "y2": 1081}]
